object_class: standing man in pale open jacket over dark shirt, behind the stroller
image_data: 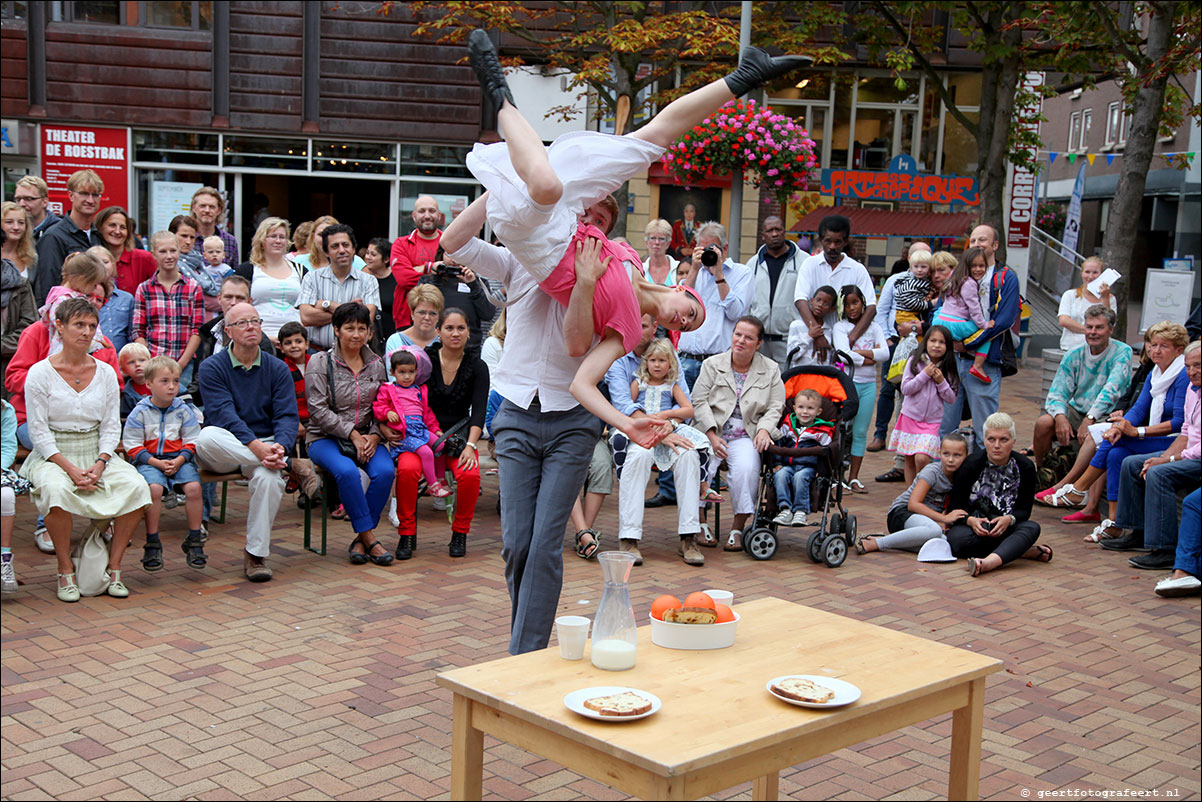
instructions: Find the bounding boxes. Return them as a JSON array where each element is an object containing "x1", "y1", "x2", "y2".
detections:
[{"x1": 748, "y1": 214, "x2": 807, "y2": 370}]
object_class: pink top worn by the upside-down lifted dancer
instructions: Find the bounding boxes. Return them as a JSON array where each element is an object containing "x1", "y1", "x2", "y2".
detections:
[{"x1": 538, "y1": 222, "x2": 643, "y2": 354}]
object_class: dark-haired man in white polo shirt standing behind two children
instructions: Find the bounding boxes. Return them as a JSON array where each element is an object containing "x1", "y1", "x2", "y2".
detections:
[{"x1": 795, "y1": 214, "x2": 876, "y2": 361}]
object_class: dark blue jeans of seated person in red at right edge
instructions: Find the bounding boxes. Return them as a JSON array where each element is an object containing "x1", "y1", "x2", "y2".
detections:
[{"x1": 1114, "y1": 453, "x2": 1202, "y2": 551}]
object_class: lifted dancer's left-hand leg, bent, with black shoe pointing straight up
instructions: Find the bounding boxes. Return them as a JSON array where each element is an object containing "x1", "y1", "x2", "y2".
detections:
[{"x1": 468, "y1": 29, "x2": 564, "y2": 206}]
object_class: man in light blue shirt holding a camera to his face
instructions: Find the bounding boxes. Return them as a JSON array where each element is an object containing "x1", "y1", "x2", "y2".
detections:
[{"x1": 677, "y1": 221, "x2": 755, "y2": 390}]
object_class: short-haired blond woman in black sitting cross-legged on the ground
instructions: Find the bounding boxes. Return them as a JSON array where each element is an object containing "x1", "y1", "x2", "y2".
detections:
[{"x1": 947, "y1": 412, "x2": 1052, "y2": 576}]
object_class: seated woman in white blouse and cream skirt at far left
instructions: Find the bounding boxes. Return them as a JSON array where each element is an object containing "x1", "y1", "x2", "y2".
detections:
[{"x1": 20, "y1": 298, "x2": 150, "y2": 601}]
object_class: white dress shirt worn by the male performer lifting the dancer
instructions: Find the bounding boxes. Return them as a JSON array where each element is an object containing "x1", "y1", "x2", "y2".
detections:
[{"x1": 447, "y1": 239, "x2": 586, "y2": 412}]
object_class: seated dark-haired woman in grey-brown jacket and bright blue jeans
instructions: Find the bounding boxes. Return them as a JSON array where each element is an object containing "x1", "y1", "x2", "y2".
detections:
[{"x1": 304, "y1": 303, "x2": 394, "y2": 565}]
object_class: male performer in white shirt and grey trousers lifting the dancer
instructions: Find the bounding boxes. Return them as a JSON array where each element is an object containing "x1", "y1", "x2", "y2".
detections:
[{"x1": 442, "y1": 195, "x2": 601, "y2": 654}]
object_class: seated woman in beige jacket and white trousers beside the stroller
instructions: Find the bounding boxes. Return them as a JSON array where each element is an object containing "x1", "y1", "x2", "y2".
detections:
[{"x1": 680, "y1": 315, "x2": 785, "y2": 557}]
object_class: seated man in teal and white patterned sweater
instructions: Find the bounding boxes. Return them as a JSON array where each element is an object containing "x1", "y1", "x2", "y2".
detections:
[{"x1": 1031, "y1": 304, "x2": 1131, "y2": 513}]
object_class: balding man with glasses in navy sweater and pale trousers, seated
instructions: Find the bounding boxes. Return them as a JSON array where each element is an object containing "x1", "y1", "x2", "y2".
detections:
[{"x1": 196, "y1": 303, "x2": 301, "y2": 582}]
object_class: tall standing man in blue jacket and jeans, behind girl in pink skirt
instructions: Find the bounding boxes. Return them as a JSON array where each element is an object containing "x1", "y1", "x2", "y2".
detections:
[{"x1": 939, "y1": 226, "x2": 1022, "y2": 448}]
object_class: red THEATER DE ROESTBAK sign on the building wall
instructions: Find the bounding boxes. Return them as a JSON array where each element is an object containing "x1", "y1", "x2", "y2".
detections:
[{"x1": 40, "y1": 125, "x2": 130, "y2": 215}]
